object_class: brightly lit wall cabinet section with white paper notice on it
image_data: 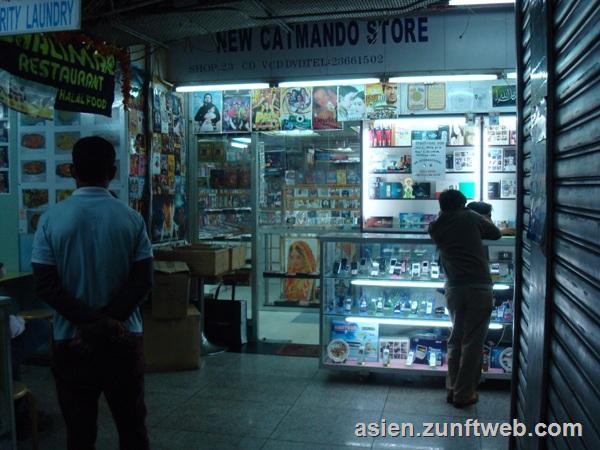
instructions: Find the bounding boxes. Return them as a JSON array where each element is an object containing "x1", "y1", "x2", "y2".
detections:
[{"x1": 362, "y1": 115, "x2": 481, "y2": 233}]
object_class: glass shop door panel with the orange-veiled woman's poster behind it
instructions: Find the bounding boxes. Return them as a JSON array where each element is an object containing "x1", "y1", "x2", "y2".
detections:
[{"x1": 256, "y1": 123, "x2": 361, "y2": 312}]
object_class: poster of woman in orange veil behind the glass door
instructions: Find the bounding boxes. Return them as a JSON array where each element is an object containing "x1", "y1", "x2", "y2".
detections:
[{"x1": 283, "y1": 239, "x2": 317, "y2": 305}]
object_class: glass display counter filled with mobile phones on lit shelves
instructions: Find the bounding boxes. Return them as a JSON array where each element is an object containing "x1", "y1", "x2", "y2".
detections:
[{"x1": 320, "y1": 233, "x2": 515, "y2": 379}]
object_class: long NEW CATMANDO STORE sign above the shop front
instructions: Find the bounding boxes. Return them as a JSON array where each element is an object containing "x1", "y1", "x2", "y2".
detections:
[{"x1": 169, "y1": 10, "x2": 516, "y2": 84}]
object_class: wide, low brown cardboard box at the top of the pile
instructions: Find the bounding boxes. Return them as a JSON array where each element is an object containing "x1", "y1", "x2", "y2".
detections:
[{"x1": 154, "y1": 244, "x2": 229, "y2": 276}]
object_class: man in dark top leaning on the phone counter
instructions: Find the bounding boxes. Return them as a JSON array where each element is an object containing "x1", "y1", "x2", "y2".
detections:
[{"x1": 429, "y1": 190, "x2": 501, "y2": 408}]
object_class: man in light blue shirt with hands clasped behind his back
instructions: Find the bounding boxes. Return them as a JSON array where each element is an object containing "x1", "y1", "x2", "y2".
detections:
[{"x1": 32, "y1": 137, "x2": 152, "y2": 450}]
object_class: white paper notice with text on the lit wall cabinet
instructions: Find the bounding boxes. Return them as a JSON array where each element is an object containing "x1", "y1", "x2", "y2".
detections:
[{"x1": 411, "y1": 139, "x2": 446, "y2": 181}]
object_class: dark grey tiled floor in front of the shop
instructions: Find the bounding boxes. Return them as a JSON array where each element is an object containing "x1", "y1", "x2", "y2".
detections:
[{"x1": 19, "y1": 353, "x2": 509, "y2": 450}]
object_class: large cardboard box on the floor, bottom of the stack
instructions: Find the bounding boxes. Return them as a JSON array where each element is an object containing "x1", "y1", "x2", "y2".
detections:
[{"x1": 142, "y1": 306, "x2": 201, "y2": 372}]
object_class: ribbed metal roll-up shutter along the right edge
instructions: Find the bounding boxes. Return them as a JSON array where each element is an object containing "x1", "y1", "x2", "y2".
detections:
[{"x1": 546, "y1": 0, "x2": 600, "y2": 449}]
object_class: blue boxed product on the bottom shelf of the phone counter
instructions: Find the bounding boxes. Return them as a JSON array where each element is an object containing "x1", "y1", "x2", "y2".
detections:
[{"x1": 330, "y1": 320, "x2": 379, "y2": 362}]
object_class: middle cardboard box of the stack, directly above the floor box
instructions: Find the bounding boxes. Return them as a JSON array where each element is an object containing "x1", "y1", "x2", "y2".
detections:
[{"x1": 152, "y1": 261, "x2": 190, "y2": 319}]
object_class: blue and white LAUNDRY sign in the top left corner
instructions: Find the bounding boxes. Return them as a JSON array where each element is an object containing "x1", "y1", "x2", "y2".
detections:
[{"x1": 0, "y1": 0, "x2": 81, "y2": 36}]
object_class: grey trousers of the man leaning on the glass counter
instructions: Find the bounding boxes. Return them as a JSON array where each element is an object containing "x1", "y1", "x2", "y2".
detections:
[{"x1": 446, "y1": 286, "x2": 493, "y2": 403}]
